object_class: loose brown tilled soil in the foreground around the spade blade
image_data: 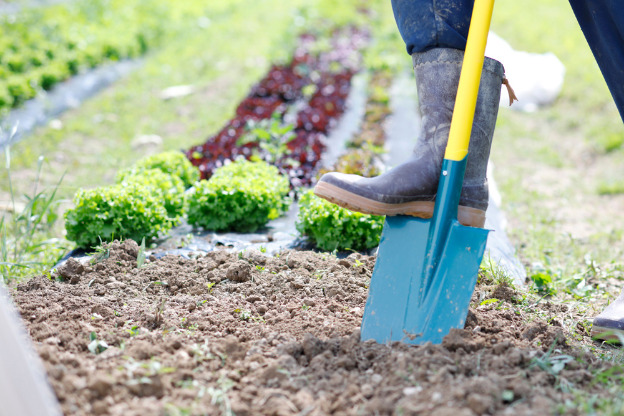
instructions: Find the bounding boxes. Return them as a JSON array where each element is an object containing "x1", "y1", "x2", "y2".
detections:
[{"x1": 13, "y1": 240, "x2": 605, "y2": 416}]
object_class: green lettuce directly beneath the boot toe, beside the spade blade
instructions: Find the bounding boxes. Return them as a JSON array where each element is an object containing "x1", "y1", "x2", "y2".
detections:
[{"x1": 297, "y1": 191, "x2": 384, "y2": 251}]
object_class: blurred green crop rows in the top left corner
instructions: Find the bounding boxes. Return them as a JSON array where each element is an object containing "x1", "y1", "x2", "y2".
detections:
[{"x1": 0, "y1": 0, "x2": 238, "y2": 115}]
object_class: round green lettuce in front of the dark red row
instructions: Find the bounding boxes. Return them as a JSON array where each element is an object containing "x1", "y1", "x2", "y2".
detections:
[{"x1": 187, "y1": 159, "x2": 289, "y2": 232}]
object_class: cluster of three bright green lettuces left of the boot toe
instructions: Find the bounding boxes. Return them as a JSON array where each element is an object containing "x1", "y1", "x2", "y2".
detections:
[{"x1": 65, "y1": 151, "x2": 290, "y2": 248}]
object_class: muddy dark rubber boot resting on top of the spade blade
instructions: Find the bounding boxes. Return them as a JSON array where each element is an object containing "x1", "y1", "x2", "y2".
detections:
[{"x1": 314, "y1": 48, "x2": 504, "y2": 227}]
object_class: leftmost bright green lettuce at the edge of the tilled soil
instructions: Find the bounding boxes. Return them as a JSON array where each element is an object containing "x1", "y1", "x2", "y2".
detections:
[{"x1": 65, "y1": 182, "x2": 173, "y2": 247}]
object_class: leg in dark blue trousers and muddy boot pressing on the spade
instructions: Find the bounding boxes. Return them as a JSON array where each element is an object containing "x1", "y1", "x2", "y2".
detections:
[{"x1": 314, "y1": 0, "x2": 503, "y2": 227}]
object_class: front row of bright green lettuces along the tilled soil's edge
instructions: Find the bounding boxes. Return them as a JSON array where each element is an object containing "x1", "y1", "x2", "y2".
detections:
[{"x1": 65, "y1": 151, "x2": 383, "y2": 250}]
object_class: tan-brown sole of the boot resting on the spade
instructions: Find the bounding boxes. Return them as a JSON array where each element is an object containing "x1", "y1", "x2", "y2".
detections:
[{"x1": 314, "y1": 182, "x2": 485, "y2": 228}]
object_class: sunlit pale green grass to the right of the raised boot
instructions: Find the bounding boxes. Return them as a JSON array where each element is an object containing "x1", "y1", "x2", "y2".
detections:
[{"x1": 492, "y1": 0, "x2": 624, "y2": 414}]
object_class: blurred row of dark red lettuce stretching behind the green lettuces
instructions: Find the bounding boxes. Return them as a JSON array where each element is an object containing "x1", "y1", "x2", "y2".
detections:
[{"x1": 186, "y1": 28, "x2": 366, "y2": 187}]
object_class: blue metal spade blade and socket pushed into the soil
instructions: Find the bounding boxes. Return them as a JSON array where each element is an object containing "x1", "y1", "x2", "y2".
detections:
[{"x1": 361, "y1": 159, "x2": 489, "y2": 344}]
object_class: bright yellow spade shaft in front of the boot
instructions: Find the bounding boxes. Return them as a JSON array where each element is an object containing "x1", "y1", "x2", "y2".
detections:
[{"x1": 444, "y1": 0, "x2": 494, "y2": 161}]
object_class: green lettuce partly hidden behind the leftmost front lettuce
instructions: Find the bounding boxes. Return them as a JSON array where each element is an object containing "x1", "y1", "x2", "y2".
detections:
[{"x1": 117, "y1": 150, "x2": 199, "y2": 188}]
